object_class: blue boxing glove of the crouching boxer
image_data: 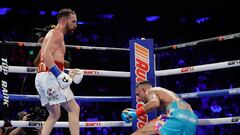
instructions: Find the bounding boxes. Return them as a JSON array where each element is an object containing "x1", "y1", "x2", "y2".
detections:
[{"x1": 121, "y1": 108, "x2": 137, "y2": 123}]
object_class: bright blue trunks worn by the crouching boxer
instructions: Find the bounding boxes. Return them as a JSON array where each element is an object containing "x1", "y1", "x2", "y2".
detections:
[{"x1": 155, "y1": 100, "x2": 198, "y2": 135}]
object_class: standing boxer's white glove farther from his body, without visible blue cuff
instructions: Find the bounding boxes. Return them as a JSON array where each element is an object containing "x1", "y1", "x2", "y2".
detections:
[{"x1": 68, "y1": 68, "x2": 84, "y2": 84}]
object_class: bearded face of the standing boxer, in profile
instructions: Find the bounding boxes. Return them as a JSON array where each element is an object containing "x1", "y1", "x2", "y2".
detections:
[{"x1": 65, "y1": 14, "x2": 77, "y2": 34}]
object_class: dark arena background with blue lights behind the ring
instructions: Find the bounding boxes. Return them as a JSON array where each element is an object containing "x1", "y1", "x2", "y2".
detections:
[{"x1": 0, "y1": 0, "x2": 240, "y2": 135}]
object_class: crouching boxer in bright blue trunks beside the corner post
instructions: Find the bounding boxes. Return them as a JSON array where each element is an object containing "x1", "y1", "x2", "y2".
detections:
[{"x1": 122, "y1": 81, "x2": 198, "y2": 135}]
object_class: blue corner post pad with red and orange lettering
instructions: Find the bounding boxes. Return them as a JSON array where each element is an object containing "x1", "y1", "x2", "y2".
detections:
[{"x1": 129, "y1": 39, "x2": 157, "y2": 131}]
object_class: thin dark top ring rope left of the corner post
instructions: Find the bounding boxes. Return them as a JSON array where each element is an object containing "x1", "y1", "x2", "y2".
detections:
[{"x1": 0, "y1": 41, "x2": 129, "y2": 51}]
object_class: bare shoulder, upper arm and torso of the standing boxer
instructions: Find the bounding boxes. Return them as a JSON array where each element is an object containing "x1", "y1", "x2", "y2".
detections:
[{"x1": 41, "y1": 29, "x2": 66, "y2": 67}]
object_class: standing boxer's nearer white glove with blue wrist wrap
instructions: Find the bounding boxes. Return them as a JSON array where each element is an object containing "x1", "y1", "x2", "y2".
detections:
[{"x1": 50, "y1": 65, "x2": 73, "y2": 89}]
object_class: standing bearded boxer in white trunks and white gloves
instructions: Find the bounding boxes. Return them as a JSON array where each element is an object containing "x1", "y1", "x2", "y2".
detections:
[{"x1": 35, "y1": 9, "x2": 83, "y2": 135}]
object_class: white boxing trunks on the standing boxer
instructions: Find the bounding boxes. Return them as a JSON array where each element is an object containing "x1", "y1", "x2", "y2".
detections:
[{"x1": 35, "y1": 72, "x2": 74, "y2": 106}]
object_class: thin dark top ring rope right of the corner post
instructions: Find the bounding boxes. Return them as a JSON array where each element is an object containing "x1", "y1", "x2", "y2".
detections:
[{"x1": 154, "y1": 33, "x2": 240, "y2": 52}]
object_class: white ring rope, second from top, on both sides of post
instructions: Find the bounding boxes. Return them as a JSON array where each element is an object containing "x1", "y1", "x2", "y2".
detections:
[{"x1": 0, "y1": 60, "x2": 240, "y2": 77}]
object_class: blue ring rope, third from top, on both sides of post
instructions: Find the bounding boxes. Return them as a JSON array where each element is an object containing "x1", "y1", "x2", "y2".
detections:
[{"x1": 0, "y1": 88, "x2": 240, "y2": 102}]
